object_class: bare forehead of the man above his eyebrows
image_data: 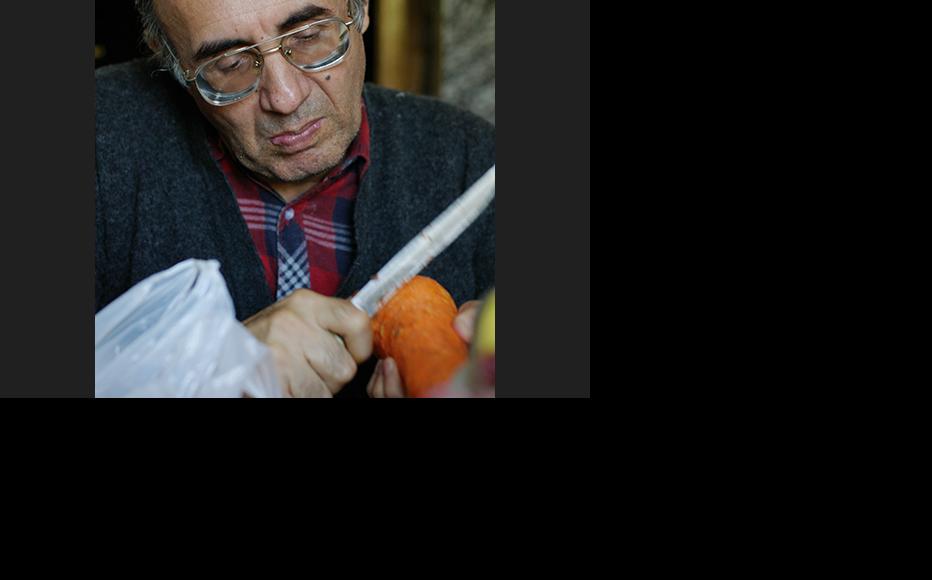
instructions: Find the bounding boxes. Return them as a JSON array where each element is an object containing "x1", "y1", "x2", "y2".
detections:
[{"x1": 157, "y1": 0, "x2": 345, "y2": 46}]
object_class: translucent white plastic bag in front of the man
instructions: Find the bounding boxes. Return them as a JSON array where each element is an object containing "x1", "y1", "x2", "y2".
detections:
[{"x1": 94, "y1": 259, "x2": 281, "y2": 397}]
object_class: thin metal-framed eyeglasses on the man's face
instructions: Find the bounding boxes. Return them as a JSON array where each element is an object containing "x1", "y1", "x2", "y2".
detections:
[{"x1": 184, "y1": 18, "x2": 353, "y2": 107}]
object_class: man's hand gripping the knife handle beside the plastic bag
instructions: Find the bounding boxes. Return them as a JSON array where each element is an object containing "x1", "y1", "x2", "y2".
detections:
[{"x1": 243, "y1": 290, "x2": 372, "y2": 397}]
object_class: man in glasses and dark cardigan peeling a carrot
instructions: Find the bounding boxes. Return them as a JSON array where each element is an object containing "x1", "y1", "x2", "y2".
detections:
[{"x1": 96, "y1": 0, "x2": 495, "y2": 397}]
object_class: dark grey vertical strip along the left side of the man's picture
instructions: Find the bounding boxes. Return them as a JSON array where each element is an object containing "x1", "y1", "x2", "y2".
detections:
[{"x1": 0, "y1": 2, "x2": 94, "y2": 397}]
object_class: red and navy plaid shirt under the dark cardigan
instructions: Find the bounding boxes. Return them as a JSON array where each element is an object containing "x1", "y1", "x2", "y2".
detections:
[{"x1": 208, "y1": 105, "x2": 369, "y2": 300}]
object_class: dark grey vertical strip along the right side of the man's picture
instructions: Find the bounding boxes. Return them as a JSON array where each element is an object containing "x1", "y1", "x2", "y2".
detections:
[{"x1": 495, "y1": 0, "x2": 588, "y2": 397}]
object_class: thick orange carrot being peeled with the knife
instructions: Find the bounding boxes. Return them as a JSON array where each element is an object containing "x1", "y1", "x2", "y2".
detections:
[{"x1": 372, "y1": 276, "x2": 469, "y2": 397}]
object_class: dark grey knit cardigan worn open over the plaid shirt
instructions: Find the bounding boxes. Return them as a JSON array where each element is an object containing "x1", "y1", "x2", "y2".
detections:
[{"x1": 95, "y1": 60, "x2": 495, "y2": 320}]
